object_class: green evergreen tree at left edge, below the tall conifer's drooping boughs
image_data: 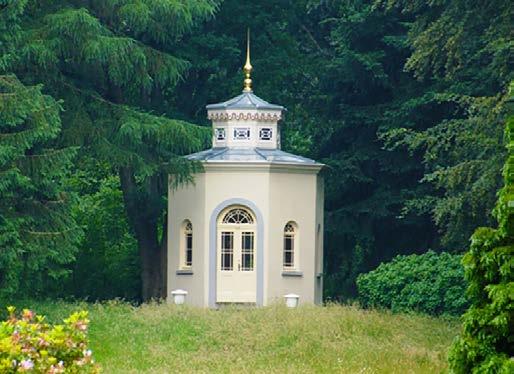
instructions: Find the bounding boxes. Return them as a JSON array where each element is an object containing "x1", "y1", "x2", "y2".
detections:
[{"x1": 0, "y1": 75, "x2": 81, "y2": 297}]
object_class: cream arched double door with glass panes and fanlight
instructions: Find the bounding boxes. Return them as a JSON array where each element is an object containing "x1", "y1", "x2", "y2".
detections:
[{"x1": 216, "y1": 206, "x2": 257, "y2": 303}]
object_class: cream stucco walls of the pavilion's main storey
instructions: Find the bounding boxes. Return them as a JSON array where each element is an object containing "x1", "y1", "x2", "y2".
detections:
[{"x1": 168, "y1": 164, "x2": 323, "y2": 306}]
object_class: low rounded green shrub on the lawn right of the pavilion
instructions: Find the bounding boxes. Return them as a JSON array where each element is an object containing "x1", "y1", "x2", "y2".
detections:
[{"x1": 357, "y1": 251, "x2": 467, "y2": 315}]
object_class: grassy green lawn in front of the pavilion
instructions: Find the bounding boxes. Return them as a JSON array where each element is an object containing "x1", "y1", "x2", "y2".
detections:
[{"x1": 3, "y1": 302, "x2": 459, "y2": 373}]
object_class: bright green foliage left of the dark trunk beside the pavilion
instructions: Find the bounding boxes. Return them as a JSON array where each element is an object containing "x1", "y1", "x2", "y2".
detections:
[{"x1": 64, "y1": 169, "x2": 141, "y2": 300}]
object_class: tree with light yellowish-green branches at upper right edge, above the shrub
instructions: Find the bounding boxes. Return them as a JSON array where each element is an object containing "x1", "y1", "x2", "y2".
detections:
[{"x1": 375, "y1": 0, "x2": 514, "y2": 250}]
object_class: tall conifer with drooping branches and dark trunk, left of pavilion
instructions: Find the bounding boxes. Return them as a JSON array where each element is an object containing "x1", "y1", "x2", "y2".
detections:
[{"x1": 1, "y1": 0, "x2": 216, "y2": 300}]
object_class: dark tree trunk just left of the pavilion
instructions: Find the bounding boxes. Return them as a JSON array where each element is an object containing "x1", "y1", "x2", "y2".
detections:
[{"x1": 119, "y1": 167, "x2": 166, "y2": 301}]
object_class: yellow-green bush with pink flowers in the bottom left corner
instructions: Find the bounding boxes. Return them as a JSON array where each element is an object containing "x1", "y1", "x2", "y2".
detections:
[{"x1": 0, "y1": 307, "x2": 100, "y2": 374}]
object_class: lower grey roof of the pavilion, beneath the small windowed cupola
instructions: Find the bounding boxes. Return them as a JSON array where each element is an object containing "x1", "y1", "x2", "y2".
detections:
[{"x1": 186, "y1": 147, "x2": 323, "y2": 166}]
